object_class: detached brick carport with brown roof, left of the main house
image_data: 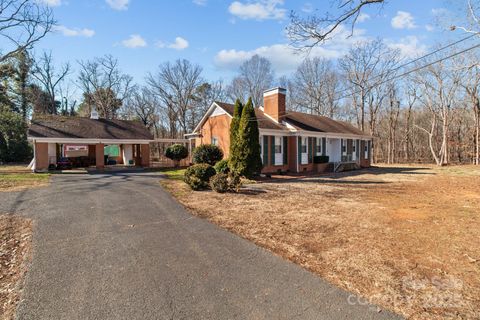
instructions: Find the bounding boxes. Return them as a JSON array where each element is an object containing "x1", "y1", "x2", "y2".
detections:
[{"x1": 28, "y1": 114, "x2": 153, "y2": 171}]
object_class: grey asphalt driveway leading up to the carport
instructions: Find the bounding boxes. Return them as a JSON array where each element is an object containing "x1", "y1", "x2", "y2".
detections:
[{"x1": 0, "y1": 173, "x2": 399, "y2": 320}]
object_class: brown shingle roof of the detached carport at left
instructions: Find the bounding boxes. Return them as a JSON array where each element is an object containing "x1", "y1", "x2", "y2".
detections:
[{"x1": 28, "y1": 115, "x2": 153, "y2": 140}]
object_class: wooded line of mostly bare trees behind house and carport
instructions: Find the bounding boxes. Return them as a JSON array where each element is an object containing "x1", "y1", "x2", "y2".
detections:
[{"x1": 0, "y1": 0, "x2": 480, "y2": 164}]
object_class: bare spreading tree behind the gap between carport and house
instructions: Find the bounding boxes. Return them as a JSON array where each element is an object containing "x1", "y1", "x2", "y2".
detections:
[{"x1": 147, "y1": 60, "x2": 203, "y2": 137}]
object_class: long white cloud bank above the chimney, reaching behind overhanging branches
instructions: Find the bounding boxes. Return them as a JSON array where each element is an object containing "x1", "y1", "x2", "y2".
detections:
[{"x1": 214, "y1": 26, "x2": 367, "y2": 74}]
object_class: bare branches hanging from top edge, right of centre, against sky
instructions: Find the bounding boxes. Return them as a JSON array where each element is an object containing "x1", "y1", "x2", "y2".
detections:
[{"x1": 287, "y1": 0, "x2": 385, "y2": 49}]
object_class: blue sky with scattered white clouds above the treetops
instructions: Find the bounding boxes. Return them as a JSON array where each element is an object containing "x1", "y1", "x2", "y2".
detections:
[{"x1": 35, "y1": 0, "x2": 468, "y2": 83}]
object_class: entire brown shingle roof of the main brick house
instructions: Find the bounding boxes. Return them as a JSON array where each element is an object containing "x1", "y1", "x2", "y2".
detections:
[{"x1": 216, "y1": 102, "x2": 365, "y2": 135}]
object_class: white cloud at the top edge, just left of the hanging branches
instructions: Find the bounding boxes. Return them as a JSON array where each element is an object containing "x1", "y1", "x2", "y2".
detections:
[{"x1": 228, "y1": 0, "x2": 287, "y2": 20}]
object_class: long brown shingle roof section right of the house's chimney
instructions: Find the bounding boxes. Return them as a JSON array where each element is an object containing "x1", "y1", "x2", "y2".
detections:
[{"x1": 285, "y1": 111, "x2": 365, "y2": 135}]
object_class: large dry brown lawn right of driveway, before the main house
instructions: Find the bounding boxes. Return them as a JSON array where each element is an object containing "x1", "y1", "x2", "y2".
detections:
[{"x1": 163, "y1": 166, "x2": 480, "y2": 319}]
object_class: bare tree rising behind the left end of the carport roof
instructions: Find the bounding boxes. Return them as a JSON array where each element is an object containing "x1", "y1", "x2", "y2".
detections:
[{"x1": 32, "y1": 52, "x2": 70, "y2": 114}]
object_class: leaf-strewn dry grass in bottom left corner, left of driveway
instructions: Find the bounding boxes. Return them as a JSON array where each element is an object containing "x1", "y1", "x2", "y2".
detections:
[{"x1": 0, "y1": 215, "x2": 32, "y2": 320}]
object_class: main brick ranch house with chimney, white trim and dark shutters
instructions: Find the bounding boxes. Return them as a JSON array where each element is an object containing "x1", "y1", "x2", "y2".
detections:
[{"x1": 186, "y1": 88, "x2": 372, "y2": 173}]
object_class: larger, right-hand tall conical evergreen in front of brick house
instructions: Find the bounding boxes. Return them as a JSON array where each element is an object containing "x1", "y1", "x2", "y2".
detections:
[{"x1": 237, "y1": 98, "x2": 262, "y2": 177}]
